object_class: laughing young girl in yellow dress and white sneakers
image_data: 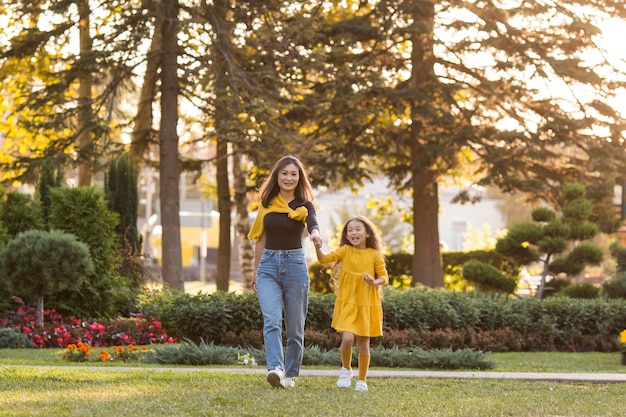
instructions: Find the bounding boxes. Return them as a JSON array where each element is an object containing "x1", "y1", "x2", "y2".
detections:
[{"x1": 314, "y1": 216, "x2": 388, "y2": 391}]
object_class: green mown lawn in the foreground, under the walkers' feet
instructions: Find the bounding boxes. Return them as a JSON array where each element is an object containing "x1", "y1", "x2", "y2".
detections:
[{"x1": 0, "y1": 349, "x2": 626, "y2": 417}]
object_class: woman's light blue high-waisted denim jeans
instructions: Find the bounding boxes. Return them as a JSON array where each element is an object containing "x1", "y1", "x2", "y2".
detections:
[{"x1": 256, "y1": 249, "x2": 310, "y2": 378}]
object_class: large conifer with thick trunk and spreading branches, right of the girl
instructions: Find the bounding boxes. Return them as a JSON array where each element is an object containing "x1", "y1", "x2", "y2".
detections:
[{"x1": 282, "y1": 0, "x2": 626, "y2": 286}]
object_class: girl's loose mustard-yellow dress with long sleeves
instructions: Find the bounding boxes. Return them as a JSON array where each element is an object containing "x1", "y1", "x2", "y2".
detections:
[{"x1": 319, "y1": 245, "x2": 389, "y2": 337}]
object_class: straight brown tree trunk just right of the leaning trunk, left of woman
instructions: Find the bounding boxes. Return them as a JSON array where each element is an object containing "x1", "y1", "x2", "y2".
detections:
[{"x1": 159, "y1": 0, "x2": 185, "y2": 291}]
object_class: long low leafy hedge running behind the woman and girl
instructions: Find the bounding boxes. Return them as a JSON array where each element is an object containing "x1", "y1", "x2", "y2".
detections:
[{"x1": 142, "y1": 289, "x2": 626, "y2": 351}]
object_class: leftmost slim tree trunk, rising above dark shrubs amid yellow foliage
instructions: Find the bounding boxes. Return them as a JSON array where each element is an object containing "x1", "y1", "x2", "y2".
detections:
[{"x1": 77, "y1": 0, "x2": 94, "y2": 187}]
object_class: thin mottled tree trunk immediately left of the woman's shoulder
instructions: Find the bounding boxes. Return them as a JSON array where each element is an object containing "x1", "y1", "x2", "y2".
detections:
[{"x1": 233, "y1": 149, "x2": 254, "y2": 290}]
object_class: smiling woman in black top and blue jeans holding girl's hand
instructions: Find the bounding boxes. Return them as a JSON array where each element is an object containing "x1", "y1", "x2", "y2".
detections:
[{"x1": 248, "y1": 156, "x2": 321, "y2": 388}]
